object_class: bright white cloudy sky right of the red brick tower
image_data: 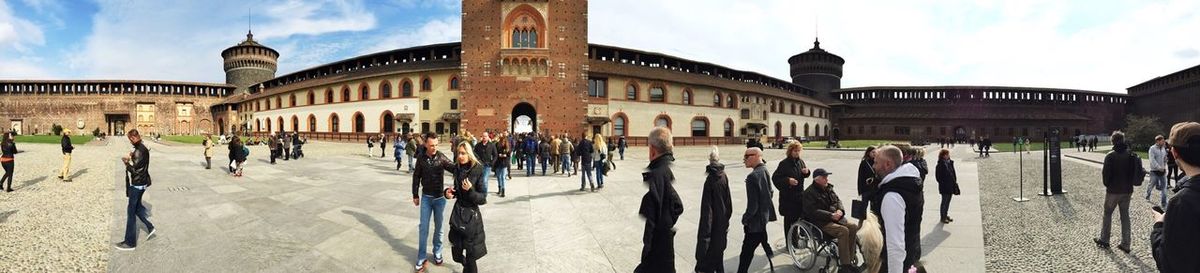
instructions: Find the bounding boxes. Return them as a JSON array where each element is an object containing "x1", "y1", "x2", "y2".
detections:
[{"x1": 588, "y1": 0, "x2": 1200, "y2": 92}]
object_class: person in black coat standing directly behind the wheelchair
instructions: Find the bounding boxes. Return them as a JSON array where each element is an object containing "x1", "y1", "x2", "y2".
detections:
[{"x1": 770, "y1": 142, "x2": 809, "y2": 235}]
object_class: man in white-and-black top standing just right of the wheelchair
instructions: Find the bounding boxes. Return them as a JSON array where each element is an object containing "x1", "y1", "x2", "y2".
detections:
[{"x1": 871, "y1": 144, "x2": 916, "y2": 273}]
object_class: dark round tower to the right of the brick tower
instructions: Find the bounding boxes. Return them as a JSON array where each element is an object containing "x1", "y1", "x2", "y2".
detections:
[{"x1": 787, "y1": 40, "x2": 846, "y2": 102}]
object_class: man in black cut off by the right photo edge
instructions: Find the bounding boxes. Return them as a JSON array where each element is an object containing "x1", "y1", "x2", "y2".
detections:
[{"x1": 1150, "y1": 122, "x2": 1200, "y2": 273}]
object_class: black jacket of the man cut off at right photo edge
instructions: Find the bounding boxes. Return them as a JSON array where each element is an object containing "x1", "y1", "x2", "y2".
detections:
[{"x1": 1150, "y1": 175, "x2": 1200, "y2": 273}]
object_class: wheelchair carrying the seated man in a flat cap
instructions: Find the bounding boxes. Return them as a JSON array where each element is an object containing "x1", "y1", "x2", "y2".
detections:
[{"x1": 786, "y1": 219, "x2": 865, "y2": 273}]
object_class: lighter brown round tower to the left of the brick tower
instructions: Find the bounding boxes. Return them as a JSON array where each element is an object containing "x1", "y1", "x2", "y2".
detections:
[{"x1": 221, "y1": 32, "x2": 280, "y2": 93}]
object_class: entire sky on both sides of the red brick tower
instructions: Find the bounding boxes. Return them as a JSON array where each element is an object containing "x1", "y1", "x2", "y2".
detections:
[{"x1": 0, "y1": 0, "x2": 1200, "y2": 92}]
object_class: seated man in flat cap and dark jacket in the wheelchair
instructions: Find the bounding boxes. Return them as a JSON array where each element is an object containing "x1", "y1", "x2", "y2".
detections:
[{"x1": 800, "y1": 169, "x2": 858, "y2": 272}]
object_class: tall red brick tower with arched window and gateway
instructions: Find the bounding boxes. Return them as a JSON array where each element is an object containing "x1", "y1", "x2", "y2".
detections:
[{"x1": 461, "y1": 0, "x2": 588, "y2": 134}]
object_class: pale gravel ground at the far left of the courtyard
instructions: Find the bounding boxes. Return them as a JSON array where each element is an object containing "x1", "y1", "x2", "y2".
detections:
[{"x1": 0, "y1": 141, "x2": 118, "y2": 272}]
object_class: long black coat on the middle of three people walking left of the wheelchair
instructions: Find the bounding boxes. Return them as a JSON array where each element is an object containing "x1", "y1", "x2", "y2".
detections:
[{"x1": 696, "y1": 163, "x2": 733, "y2": 265}]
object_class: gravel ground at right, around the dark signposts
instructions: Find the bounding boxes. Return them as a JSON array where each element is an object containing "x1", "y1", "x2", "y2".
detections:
[{"x1": 965, "y1": 150, "x2": 1157, "y2": 272}]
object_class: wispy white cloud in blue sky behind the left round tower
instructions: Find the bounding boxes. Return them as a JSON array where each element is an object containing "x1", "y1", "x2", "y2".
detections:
[{"x1": 68, "y1": 0, "x2": 376, "y2": 83}]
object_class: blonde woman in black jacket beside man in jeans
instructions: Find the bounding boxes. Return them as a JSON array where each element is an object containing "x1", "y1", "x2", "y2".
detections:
[{"x1": 445, "y1": 141, "x2": 487, "y2": 273}]
